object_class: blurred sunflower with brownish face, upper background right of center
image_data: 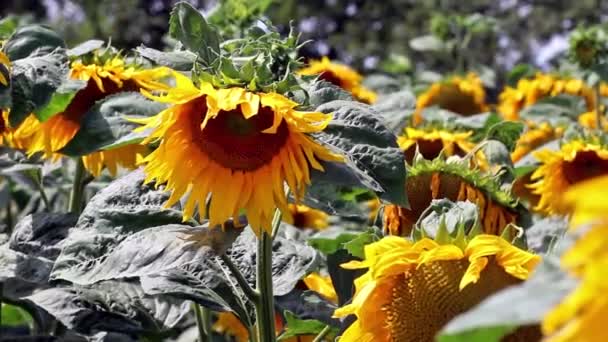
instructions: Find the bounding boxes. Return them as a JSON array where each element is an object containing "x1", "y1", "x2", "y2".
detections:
[{"x1": 414, "y1": 73, "x2": 489, "y2": 125}]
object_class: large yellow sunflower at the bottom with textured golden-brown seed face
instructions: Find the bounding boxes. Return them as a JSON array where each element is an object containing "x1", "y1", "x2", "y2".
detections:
[{"x1": 334, "y1": 234, "x2": 540, "y2": 342}]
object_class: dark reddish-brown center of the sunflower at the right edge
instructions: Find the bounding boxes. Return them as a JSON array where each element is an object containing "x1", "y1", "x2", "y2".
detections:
[{"x1": 562, "y1": 151, "x2": 608, "y2": 184}]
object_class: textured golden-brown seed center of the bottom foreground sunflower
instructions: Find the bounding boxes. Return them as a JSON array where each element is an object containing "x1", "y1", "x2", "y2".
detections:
[{"x1": 382, "y1": 258, "x2": 519, "y2": 342}]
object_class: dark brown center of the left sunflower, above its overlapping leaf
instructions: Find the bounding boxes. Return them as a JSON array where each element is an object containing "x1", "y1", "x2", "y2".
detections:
[{"x1": 63, "y1": 77, "x2": 140, "y2": 123}]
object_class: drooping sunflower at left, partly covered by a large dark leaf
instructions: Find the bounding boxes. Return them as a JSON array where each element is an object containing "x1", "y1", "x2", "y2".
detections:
[{"x1": 28, "y1": 56, "x2": 169, "y2": 176}]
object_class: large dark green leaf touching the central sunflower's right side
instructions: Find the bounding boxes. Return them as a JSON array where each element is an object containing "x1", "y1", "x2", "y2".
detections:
[{"x1": 313, "y1": 100, "x2": 408, "y2": 207}]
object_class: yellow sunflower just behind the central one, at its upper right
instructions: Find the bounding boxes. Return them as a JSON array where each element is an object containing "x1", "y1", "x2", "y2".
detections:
[{"x1": 298, "y1": 57, "x2": 377, "y2": 104}]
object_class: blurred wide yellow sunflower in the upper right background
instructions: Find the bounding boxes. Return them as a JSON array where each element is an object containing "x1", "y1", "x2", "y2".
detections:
[{"x1": 498, "y1": 73, "x2": 608, "y2": 120}]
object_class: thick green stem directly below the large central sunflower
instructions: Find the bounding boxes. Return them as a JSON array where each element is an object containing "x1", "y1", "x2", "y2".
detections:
[{"x1": 255, "y1": 210, "x2": 281, "y2": 342}]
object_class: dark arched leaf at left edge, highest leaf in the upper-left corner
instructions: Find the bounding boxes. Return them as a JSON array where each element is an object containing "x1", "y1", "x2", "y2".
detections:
[{"x1": 2, "y1": 25, "x2": 66, "y2": 61}]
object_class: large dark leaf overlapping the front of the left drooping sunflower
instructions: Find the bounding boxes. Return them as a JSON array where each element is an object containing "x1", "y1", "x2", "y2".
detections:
[{"x1": 61, "y1": 92, "x2": 165, "y2": 156}]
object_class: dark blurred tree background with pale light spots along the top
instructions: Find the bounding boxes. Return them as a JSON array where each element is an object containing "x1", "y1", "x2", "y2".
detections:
[{"x1": 0, "y1": 0, "x2": 608, "y2": 75}]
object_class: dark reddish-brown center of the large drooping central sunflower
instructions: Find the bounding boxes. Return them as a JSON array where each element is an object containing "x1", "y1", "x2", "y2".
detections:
[{"x1": 191, "y1": 97, "x2": 289, "y2": 171}]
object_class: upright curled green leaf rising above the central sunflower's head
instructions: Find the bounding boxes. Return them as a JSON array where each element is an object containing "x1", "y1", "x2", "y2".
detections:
[{"x1": 169, "y1": 2, "x2": 220, "y2": 65}]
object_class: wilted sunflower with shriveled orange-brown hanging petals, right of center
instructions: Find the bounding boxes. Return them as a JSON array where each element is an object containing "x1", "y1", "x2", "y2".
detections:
[{"x1": 383, "y1": 158, "x2": 518, "y2": 236}]
